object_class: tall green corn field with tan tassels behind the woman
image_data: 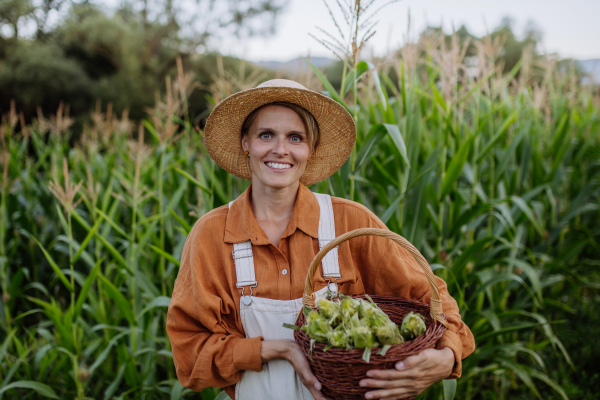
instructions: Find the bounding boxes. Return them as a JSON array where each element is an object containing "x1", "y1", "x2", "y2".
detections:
[{"x1": 0, "y1": 32, "x2": 600, "y2": 400}]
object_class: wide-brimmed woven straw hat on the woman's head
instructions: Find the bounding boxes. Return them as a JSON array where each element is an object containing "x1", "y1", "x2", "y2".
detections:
[{"x1": 204, "y1": 79, "x2": 356, "y2": 186}]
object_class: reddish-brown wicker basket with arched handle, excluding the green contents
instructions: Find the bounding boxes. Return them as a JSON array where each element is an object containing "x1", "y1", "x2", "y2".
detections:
[{"x1": 294, "y1": 228, "x2": 448, "y2": 400}]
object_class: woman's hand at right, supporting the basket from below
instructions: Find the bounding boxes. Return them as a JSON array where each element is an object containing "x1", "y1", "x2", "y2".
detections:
[{"x1": 360, "y1": 347, "x2": 454, "y2": 400}]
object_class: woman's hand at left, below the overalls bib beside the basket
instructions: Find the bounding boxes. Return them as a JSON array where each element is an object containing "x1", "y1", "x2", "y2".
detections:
[{"x1": 260, "y1": 340, "x2": 327, "y2": 400}]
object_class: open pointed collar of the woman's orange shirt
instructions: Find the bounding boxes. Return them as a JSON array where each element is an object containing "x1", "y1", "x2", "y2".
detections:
[{"x1": 224, "y1": 184, "x2": 320, "y2": 245}]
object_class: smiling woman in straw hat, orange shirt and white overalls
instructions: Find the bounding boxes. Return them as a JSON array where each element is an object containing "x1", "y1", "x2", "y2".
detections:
[{"x1": 167, "y1": 79, "x2": 474, "y2": 400}]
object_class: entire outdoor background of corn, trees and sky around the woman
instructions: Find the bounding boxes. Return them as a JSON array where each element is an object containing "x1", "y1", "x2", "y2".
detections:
[{"x1": 0, "y1": 0, "x2": 600, "y2": 400}]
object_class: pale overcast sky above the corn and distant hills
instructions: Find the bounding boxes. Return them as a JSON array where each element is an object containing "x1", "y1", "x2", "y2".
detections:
[{"x1": 219, "y1": 0, "x2": 600, "y2": 61}]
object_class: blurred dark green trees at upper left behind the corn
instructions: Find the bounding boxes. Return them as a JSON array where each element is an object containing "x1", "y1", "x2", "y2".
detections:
[{"x1": 0, "y1": 0, "x2": 282, "y2": 121}]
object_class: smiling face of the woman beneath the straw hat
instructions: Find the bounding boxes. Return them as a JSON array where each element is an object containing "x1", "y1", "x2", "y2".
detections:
[{"x1": 242, "y1": 105, "x2": 310, "y2": 189}]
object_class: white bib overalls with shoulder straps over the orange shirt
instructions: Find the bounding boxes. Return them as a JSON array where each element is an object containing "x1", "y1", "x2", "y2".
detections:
[{"x1": 229, "y1": 193, "x2": 341, "y2": 400}]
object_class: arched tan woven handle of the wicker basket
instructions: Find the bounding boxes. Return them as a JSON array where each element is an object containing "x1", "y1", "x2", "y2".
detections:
[{"x1": 302, "y1": 228, "x2": 448, "y2": 328}]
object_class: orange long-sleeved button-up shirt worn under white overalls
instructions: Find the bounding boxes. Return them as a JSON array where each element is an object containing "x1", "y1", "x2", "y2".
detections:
[{"x1": 167, "y1": 185, "x2": 475, "y2": 398}]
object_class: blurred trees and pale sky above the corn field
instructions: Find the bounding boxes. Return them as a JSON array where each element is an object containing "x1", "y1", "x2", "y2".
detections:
[{"x1": 0, "y1": 0, "x2": 600, "y2": 121}]
